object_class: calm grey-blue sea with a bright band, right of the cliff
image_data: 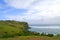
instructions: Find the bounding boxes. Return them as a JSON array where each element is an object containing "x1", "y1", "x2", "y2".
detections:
[{"x1": 29, "y1": 26, "x2": 60, "y2": 34}]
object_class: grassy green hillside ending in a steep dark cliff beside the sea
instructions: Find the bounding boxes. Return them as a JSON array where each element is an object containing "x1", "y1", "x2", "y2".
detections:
[{"x1": 0, "y1": 20, "x2": 29, "y2": 37}]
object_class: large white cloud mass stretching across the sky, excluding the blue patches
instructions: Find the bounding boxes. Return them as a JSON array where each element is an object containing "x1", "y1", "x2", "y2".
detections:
[{"x1": 5, "y1": 0, "x2": 60, "y2": 24}]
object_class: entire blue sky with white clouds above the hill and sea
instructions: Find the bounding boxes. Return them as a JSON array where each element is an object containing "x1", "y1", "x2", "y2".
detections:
[{"x1": 0, "y1": 0, "x2": 60, "y2": 24}]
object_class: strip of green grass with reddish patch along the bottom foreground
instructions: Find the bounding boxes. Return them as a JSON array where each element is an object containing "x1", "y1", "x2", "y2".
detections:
[{"x1": 0, "y1": 36, "x2": 60, "y2": 40}]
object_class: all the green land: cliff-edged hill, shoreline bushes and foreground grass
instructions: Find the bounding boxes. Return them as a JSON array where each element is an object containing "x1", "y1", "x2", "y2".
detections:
[{"x1": 0, "y1": 20, "x2": 60, "y2": 40}]
